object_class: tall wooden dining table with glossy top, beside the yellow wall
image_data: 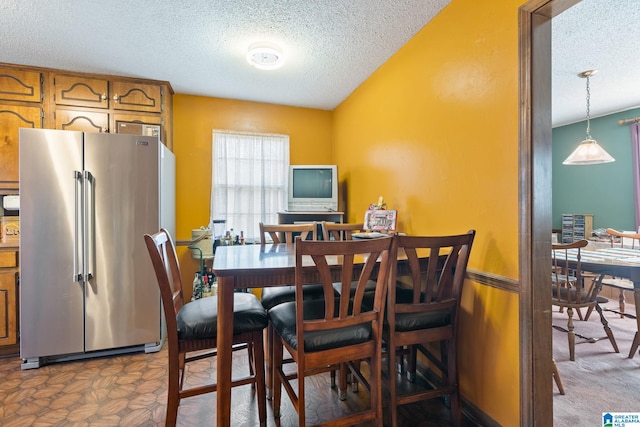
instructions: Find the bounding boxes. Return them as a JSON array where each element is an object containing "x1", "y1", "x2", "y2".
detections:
[{"x1": 213, "y1": 244, "x2": 428, "y2": 426}]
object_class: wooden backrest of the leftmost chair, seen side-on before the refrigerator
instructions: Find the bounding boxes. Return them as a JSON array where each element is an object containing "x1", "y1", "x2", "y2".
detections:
[{"x1": 144, "y1": 228, "x2": 184, "y2": 342}]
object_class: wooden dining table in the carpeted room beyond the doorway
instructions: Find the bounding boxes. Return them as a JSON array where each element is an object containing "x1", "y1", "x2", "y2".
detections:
[{"x1": 569, "y1": 246, "x2": 640, "y2": 359}]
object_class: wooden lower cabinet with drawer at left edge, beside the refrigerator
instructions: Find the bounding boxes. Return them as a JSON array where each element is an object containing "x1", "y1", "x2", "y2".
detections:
[{"x1": 0, "y1": 249, "x2": 18, "y2": 346}]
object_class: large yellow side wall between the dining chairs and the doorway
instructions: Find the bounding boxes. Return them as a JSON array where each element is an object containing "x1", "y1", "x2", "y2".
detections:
[{"x1": 332, "y1": 0, "x2": 523, "y2": 426}]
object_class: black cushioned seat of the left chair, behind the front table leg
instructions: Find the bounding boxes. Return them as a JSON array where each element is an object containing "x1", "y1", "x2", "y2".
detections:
[{"x1": 176, "y1": 292, "x2": 268, "y2": 340}]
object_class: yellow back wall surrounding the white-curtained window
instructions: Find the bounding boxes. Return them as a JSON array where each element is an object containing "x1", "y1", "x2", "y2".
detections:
[{"x1": 173, "y1": 94, "x2": 332, "y2": 284}]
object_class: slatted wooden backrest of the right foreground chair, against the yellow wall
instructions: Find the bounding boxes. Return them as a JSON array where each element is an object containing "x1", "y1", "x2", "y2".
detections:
[{"x1": 387, "y1": 230, "x2": 475, "y2": 332}]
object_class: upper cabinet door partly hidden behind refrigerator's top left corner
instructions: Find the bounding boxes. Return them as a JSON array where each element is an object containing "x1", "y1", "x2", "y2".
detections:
[{"x1": 0, "y1": 104, "x2": 42, "y2": 182}]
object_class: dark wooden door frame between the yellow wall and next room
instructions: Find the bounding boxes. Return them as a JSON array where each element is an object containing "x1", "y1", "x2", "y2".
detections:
[{"x1": 518, "y1": 0, "x2": 580, "y2": 426}]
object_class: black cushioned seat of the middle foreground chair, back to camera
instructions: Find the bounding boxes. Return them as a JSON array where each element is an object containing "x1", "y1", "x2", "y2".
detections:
[{"x1": 269, "y1": 298, "x2": 371, "y2": 352}]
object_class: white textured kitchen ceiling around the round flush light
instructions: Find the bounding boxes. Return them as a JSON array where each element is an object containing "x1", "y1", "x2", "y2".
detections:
[{"x1": 0, "y1": 0, "x2": 449, "y2": 110}]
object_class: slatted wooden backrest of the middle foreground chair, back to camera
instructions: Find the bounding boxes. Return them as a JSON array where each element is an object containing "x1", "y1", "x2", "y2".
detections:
[{"x1": 296, "y1": 237, "x2": 392, "y2": 344}]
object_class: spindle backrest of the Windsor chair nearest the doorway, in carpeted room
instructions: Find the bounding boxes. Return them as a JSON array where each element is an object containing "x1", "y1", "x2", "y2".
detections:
[{"x1": 551, "y1": 239, "x2": 603, "y2": 305}]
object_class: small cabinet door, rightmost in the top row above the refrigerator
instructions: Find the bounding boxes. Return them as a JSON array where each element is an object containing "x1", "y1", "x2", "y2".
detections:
[{"x1": 111, "y1": 81, "x2": 162, "y2": 113}]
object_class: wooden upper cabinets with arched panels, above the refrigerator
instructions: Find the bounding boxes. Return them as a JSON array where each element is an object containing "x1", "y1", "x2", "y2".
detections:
[{"x1": 0, "y1": 62, "x2": 173, "y2": 191}]
